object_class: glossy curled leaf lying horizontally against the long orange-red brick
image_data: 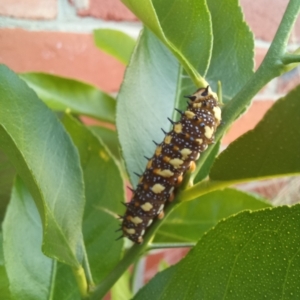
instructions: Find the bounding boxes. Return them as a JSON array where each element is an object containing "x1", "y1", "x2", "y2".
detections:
[{"x1": 20, "y1": 73, "x2": 116, "y2": 123}]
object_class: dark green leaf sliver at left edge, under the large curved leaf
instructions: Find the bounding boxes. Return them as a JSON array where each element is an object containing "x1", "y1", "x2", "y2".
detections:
[{"x1": 0, "y1": 150, "x2": 16, "y2": 224}]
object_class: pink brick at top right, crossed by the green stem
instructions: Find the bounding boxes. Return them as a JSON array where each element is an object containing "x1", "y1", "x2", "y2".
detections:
[{"x1": 241, "y1": 0, "x2": 300, "y2": 41}]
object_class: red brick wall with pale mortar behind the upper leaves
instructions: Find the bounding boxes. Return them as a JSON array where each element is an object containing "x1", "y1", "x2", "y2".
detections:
[{"x1": 0, "y1": 0, "x2": 300, "y2": 144}]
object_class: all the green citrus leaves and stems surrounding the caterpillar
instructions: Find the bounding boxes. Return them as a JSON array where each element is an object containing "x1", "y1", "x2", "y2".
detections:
[{"x1": 0, "y1": 0, "x2": 300, "y2": 300}]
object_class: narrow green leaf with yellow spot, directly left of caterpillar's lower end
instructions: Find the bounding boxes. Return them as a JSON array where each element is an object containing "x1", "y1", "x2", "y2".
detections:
[{"x1": 63, "y1": 115, "x2": 125, "y2": 282}]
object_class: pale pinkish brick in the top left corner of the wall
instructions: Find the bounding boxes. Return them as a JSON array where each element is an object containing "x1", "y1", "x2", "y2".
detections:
[{"x1": 0, "y1": 0, "x2": 57, "y2": 20}]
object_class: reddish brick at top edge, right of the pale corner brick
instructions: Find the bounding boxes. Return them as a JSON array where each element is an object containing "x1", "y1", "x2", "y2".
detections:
[{"x1": 77, "y1": 0, "x2": 137, "y2": 21}]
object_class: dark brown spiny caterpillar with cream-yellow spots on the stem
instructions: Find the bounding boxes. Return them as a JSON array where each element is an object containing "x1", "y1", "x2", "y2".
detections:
[{"x1": 120, "y1": 86, "x2": 221, "y2": 244}]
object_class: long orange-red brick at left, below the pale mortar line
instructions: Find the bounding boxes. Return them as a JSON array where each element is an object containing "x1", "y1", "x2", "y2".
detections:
[{"x1": 0, "y1": 29, "x2": 125, "y2": 92}]
